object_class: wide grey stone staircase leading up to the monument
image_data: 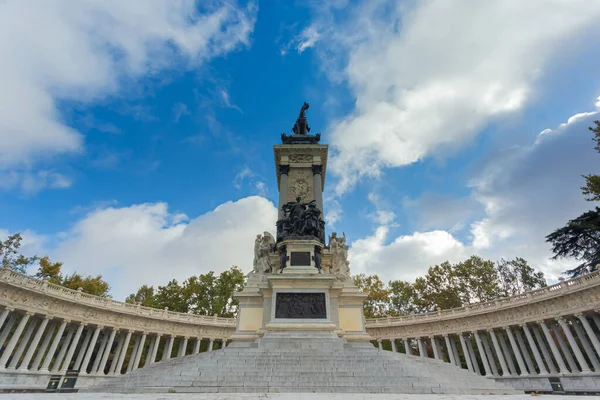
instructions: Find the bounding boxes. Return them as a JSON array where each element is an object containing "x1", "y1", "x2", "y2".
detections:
[{"x1": 82, "y1": 337, "x2": 522, "y2": 394}]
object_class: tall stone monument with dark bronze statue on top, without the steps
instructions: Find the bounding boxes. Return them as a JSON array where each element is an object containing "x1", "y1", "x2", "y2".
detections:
[{"x1": 232, "y1": 103, "x2": 372, "y2": 347}]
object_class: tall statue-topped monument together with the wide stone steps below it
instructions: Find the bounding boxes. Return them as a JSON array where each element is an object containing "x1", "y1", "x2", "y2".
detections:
[{"x1": 87, "y1": 103, "x2": 516, "y2": 394}]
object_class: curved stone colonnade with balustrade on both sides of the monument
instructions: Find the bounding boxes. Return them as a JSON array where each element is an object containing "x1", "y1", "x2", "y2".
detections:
[{"x1": 0, "y1": 268, "x2": 600, "y2": 390}]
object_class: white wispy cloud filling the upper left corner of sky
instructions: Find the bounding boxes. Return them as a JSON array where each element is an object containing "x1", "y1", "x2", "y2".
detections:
[{"x1": 0, "y1": 0, "x2": 256, "y2": 181}]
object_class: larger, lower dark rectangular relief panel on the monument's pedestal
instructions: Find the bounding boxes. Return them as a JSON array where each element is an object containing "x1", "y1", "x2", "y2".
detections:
[{"x1": 275, "y1": 293, "x2": 327, "y2": 319}]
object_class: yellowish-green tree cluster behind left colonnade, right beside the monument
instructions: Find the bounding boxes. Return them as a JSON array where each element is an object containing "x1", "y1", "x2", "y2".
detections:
[{"x1": 125, "y1": 267, "x2": 246, "y2": 317}]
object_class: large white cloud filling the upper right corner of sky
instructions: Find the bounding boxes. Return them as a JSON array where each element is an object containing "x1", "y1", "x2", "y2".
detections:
[{"x1": 317, "y1": 0, "x2": 600, "y2": 194}]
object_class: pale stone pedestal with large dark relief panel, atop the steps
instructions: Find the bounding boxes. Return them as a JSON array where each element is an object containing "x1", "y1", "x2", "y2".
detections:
[{"x1": 232, "y1": 266, "x2": 371, "y2": 347}]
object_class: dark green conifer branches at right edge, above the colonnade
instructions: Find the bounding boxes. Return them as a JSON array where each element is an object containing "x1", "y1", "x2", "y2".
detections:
[{"x1": 546, "y1": 207, "x2": 600, "y2": 277}]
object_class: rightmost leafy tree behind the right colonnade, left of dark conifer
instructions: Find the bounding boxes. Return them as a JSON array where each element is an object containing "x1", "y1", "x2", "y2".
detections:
[{"x1": 496, "y1": 257, "x2": 546, "y2": 297}]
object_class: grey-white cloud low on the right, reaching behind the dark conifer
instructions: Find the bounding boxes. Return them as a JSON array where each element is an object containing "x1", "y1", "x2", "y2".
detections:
[{"x1": 350, "y1": 98, "x2": 600, "y2": 281}]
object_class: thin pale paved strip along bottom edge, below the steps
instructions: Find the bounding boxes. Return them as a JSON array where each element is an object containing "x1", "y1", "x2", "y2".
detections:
[{"x1": 0, "y1": 393, "x2": 581, "y2": 400}]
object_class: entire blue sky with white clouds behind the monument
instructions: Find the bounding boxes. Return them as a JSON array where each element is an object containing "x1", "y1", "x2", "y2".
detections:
[{"x1": 0, "y1": 0, "x2": 600, "y2": 299}]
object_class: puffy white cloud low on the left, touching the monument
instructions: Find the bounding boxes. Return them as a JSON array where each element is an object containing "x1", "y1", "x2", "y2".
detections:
[{"x1": 27, "y1": 196, "x2": 277, "y2": 300}]
